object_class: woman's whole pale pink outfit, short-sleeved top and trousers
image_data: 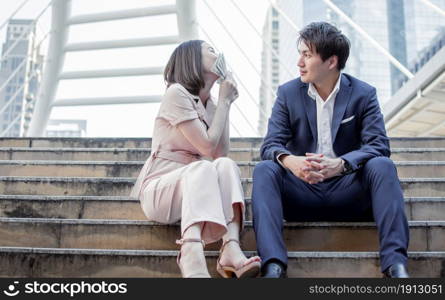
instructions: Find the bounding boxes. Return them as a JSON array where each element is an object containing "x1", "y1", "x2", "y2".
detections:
[{"x1": 131, "y1": 84, "x2": 245, "y2": 243}]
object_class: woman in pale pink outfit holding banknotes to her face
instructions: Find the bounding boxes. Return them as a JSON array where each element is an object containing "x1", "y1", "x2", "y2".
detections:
[{"x1": 131, "y1": 40, "x2": 261, "y2": 277}]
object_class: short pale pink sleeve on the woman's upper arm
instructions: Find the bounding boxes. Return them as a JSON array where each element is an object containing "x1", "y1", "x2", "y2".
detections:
[{"x1": 159, "y1": 85, "x2": 198, "y2": 126}]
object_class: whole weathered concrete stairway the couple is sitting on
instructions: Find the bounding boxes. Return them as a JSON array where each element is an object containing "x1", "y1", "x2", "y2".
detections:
[{"x1": 0, "y1": 138, "x2": 445, "y2": 277}]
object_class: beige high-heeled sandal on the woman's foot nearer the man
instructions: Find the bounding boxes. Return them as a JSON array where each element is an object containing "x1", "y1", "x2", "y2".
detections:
[{"x1": 216, "y1": 239, "x2": 261, "y2": 278}]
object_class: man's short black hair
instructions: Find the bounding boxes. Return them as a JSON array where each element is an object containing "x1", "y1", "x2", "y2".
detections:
[{"x1": 298, "y1": 22, "x2": 351, "y2": 70}]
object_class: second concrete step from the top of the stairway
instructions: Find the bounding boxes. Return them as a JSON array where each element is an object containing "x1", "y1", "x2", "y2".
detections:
[{"x1": 0, "y1": 147, "x2": 445, "y2": 161}]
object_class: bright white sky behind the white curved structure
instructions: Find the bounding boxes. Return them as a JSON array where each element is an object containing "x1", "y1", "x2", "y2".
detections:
[{"x1": 0, "y1": 0, "x2": 274, "y2": 137}]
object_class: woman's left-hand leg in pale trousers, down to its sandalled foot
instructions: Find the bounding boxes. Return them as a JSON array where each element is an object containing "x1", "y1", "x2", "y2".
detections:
[{"x1": 141, "y1": 161, "x2": 227, "y2": 277}]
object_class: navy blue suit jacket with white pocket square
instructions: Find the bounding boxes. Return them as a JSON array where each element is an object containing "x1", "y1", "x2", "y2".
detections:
[{"x1": 261, "y1": 73, "x2": 391, "y2": 171}]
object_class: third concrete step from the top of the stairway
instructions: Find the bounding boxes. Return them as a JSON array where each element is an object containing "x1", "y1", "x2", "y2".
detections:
[{"x1": 0, "y1": 160, "x2": 445, "y2": 178}]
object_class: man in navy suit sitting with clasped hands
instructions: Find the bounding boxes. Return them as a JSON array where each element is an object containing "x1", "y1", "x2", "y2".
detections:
[{"x1": 252, "y1": 22, "x2": 409, "y2": 277}]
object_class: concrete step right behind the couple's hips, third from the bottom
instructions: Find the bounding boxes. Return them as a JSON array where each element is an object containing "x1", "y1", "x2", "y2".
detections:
[{"x1": 0, "y1": 195, "x2": 445, "y2": 221}]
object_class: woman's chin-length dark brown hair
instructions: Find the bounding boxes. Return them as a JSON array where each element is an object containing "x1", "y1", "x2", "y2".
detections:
[{"x1": 164, "y1": 40, "x2": 205, "y2": 95}]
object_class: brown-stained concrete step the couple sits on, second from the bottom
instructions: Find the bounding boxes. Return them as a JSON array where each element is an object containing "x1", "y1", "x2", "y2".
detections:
[{"x1": 0, "y1": 218, "x2": 445, "y2": 251}]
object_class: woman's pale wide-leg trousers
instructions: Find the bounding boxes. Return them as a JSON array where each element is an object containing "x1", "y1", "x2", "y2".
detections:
[{"x1": 140, "y1": 157, "x2": 245, "y2": 244}]
